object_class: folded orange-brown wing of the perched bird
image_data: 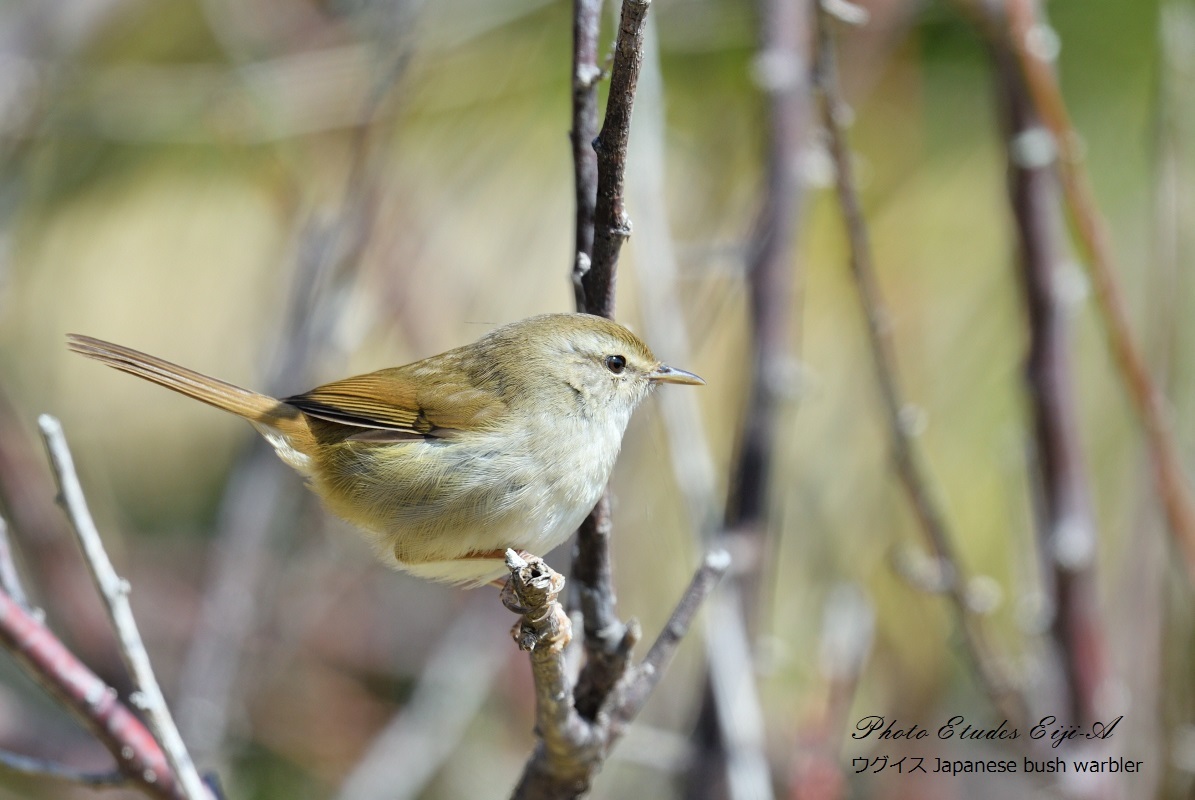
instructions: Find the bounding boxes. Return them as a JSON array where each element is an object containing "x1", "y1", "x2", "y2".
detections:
[{"x1": 284, "y1": 367, "x2": 505, "y2": 441}]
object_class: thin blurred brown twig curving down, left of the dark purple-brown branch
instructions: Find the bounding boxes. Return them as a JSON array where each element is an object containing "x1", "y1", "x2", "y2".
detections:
[{"x1": 815, "y1": 8, "x2": 1024, "y2": 720}]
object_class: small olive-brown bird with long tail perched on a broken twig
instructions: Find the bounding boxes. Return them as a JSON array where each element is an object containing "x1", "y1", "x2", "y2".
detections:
[{"x1": 67, "y1": 313, "x2": 705, "y2": 586}]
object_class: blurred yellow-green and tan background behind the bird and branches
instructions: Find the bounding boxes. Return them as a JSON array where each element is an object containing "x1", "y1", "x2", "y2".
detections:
[{"x1": 0, "y1": 0, "x2": 1195, "y2": 800}]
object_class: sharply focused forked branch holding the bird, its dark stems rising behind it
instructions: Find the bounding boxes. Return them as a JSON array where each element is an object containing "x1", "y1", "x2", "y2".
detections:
[{"x1": 525, "y1": 0, "x2": 725, "y2": 800}]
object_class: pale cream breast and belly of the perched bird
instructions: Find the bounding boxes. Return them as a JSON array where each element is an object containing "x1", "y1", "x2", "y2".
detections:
[{"x1": 263, "y1": 413, "x2": 630, "y2": 586}]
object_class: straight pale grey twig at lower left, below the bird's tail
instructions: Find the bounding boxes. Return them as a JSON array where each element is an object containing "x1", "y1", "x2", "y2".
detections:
[{"x1": 37, "y1": 414, "x2": 210, "y2": 800}]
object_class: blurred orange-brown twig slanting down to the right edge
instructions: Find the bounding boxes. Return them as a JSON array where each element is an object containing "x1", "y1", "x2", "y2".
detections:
[{"x1": 1005, "y1": 0, "x2": 1195, "y2": 581}]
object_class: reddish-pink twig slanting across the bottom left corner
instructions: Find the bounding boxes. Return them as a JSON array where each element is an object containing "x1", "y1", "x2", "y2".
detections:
[{"x1": 0, "y1": 583, "x2": 185, "y2": 800}]
